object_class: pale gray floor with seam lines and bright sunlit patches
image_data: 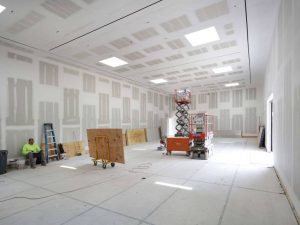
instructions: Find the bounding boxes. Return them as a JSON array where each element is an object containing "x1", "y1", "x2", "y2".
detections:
[{"x1": 0, "y1": 138, "x2": 297, "y2": 225}]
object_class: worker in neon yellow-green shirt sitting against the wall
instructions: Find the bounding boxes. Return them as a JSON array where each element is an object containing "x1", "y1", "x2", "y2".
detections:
[{"x1": 22, "y1": 138, "x2": 46, "y2": 169}]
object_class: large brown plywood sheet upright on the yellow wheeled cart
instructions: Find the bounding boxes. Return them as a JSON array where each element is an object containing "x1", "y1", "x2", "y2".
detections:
[{"x1": 87, "y1": 128, "x2": 125, "y2": 163}]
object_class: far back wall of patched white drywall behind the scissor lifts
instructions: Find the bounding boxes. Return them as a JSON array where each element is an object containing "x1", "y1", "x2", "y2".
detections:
[{"x1": 169, "y1": 88, "x2": 261, "y2": 136}]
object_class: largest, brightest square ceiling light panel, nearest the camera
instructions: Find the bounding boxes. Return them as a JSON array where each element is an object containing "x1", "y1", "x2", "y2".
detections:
[{"x1": 184, "y1": 27, "x2": 220, "y2": 46}]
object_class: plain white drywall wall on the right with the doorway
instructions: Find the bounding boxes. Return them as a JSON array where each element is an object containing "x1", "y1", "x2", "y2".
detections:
[{"x1": 264, "y1": 0, "x2": 300, "y2": 215}]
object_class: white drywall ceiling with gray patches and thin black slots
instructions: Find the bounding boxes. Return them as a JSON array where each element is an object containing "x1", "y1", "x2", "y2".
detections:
[{"x1": 0, "y1": 0, "x2": 280, "y2": 93}]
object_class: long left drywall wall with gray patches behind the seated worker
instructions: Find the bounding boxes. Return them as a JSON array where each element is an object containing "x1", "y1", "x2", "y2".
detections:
[{"x1": 0, "y1": 41, "x2": 168, "y2": 157}]
